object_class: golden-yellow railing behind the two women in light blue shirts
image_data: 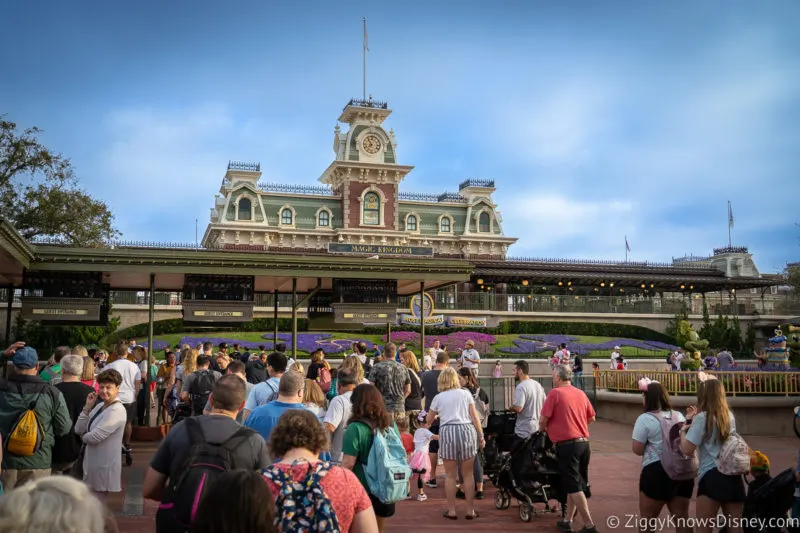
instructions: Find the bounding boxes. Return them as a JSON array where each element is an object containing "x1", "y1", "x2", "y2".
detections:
[{"x1": 595, "y1": 370, "x2": 800, "y2": 396}]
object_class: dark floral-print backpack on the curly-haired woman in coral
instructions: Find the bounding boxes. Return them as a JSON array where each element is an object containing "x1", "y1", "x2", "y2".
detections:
[{"x1": 261, "y1": 463, "x2": 341, "y2": 533}]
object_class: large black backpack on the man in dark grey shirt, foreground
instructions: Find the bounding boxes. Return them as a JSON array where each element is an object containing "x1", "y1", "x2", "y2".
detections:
[{"x1": 165, "y1": 418, "x2": 255, "y2": 528}]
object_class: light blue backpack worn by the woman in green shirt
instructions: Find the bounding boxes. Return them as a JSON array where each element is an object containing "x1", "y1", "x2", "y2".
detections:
[{"x1": 364, "y1": 427, "x2": 411, "y2": 503}]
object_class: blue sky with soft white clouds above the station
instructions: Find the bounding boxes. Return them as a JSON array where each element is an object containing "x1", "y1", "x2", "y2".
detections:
[{"x1": 0, "y1": 0, "x2": 800, "y2": 272}]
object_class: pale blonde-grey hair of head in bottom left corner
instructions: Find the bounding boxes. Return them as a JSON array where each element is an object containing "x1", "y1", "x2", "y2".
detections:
[{"x1": 0, "y1": 476, "x2": 111, "y2": 533}]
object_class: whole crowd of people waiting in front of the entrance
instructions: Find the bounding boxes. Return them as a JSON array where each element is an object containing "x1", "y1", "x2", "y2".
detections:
[{"x1": 0, "y1": 336, "x2": 788, "y2": 533}]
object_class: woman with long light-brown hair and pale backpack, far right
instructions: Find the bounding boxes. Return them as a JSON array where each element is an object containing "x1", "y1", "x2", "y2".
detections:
[{"x1": 680, "y1": 378, "x2": 750, "y2": 533}]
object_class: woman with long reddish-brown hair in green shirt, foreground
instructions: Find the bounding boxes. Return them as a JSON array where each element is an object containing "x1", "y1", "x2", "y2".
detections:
[{"x1": 342, "y1": 385, "x2": 411, "y2": 533}]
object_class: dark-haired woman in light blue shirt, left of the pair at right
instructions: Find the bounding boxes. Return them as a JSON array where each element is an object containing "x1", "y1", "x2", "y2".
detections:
[{"x1": 633, "y1": 381, "x2": 697, "y2": 532}]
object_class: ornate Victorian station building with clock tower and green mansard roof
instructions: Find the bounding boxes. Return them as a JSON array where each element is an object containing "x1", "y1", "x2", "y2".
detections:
[{"x1": 203, "y1": 99, "x2": 517, "y2": 259}]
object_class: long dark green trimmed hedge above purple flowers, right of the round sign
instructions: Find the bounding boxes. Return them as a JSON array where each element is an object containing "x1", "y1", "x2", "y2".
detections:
[{"x1": 362, "y1": 320, "x2": 675, "y2": 344}]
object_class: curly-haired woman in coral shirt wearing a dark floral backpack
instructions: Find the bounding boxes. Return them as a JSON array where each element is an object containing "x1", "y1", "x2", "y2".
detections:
[{"x1": 260, "y1": 409, "x2": 378, "y2": 533}]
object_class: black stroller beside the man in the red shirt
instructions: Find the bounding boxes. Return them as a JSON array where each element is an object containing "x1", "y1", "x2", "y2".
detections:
[{"x1": 489, "y1": 431, "x2": 567, "y2": 522}]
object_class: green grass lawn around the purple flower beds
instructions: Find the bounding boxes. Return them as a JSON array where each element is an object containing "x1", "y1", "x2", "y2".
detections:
[{"x1": 147, "y1": 331, "x2": 669, "y2": 359}]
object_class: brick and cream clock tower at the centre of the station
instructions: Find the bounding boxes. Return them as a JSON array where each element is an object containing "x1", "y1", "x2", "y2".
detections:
[{"x1": 319, "y1": 97, "x2": 414, "y2": 231}]
